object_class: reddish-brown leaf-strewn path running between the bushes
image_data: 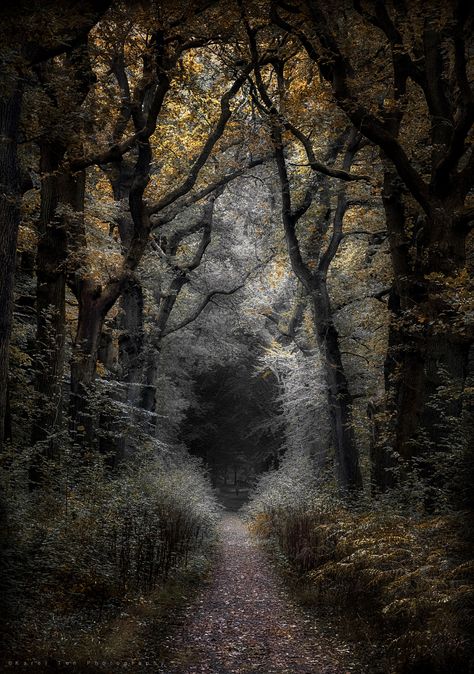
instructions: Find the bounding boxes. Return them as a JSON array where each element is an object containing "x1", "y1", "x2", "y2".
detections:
[{"x1": 157, "y1": 514, "x2": 361, "y2": 674}]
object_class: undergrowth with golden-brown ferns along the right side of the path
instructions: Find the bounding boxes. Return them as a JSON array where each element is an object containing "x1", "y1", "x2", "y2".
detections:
[{"x1": 248, "y1": 460, "x2": 474, "y2": 673}]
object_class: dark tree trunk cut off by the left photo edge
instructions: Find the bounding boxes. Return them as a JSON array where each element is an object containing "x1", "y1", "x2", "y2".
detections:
[{"x1": 0, "y1": 82, "x2": 22, "y2": 448}]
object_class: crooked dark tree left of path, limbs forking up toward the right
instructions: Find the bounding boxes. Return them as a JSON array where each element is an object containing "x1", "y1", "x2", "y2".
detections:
[{"x1": 64, "y1": 19, "x2": 260, "y2": 441}]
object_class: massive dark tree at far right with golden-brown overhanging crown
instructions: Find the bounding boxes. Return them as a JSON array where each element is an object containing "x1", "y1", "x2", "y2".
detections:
[{"x1": 272, "y1": 0, "x2": 474, "y2": 489}]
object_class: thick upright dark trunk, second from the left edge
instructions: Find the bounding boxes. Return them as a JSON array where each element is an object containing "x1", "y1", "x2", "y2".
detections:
[{"x1": 27, "y1": 41, "x2": 100, "y2": 483}]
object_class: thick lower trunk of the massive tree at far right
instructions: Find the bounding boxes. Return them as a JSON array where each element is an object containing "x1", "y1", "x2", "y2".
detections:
[{"x1": 374, "y1": 170, "x2": 472, "y2": 484}]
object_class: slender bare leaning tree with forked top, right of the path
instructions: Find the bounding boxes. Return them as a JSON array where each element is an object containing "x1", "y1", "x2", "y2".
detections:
[{"x1": 244, "y1": 25, "x2": 362, "y2": 490}]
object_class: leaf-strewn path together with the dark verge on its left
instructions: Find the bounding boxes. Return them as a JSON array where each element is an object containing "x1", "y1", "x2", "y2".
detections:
[{"x1": 5, "y1": 492, "x2": 378, "y2": 674}]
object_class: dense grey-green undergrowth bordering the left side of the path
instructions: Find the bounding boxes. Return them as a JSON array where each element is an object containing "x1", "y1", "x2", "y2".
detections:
[{"x1": 2, "y1": 440, "x2": 218, "y2": 655}]
